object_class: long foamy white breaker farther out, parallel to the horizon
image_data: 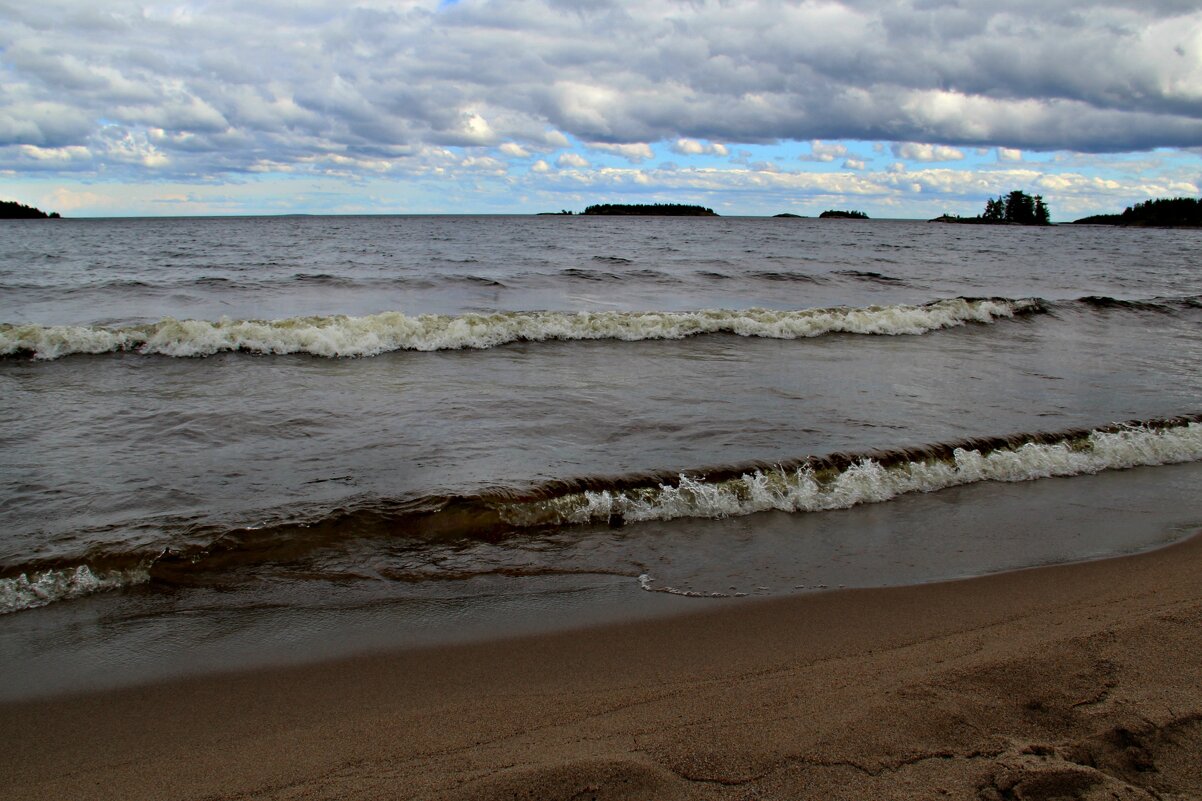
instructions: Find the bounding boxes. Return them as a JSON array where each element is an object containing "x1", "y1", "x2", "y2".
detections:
[{"x1": 0, "y1": 298, "x2": 1046, "y2": 360}]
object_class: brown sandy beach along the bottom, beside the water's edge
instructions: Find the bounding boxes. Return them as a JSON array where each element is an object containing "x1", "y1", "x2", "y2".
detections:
[{"x1": 0, "y1": 529, "x2": 1202, "y2": 801}]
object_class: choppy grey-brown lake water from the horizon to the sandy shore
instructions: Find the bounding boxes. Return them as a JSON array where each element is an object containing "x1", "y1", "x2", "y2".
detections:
[{"x1": 0, "y1": 216, "x2": 1202, "y2": 697}]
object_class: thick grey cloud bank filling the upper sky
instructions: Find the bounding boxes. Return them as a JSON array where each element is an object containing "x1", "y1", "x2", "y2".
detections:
[{"x1": 0, "y1": 0, "x2": 1202, "y2": 174}]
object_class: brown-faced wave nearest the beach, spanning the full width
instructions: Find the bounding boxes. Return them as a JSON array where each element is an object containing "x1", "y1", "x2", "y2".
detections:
[{"x1": 0, "y1": 414, "x2": 1202, "y2": 613}]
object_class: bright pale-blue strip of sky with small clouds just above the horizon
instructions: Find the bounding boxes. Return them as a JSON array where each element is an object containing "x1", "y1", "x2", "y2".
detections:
[{"x1": 9, "y1": 148, "x2": 1200, "y2": 220}]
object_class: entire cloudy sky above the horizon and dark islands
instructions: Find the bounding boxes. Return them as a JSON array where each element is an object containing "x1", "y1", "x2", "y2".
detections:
[{"x1": 0, "y1": 0, "x2": 1202, "y2": 220}]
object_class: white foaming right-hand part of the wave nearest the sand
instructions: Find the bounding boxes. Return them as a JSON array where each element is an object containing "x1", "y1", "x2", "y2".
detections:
[{"x1": 504, "y1": 422, "x2": 1202, "y2": 527}]
